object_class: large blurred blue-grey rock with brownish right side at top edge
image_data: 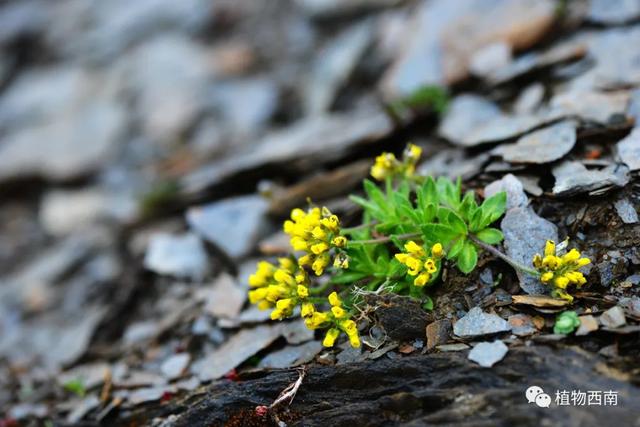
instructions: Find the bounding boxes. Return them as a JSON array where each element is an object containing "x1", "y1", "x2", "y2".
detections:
[{"x1": 383, "y1": 0, "x2": 555, "y2": 97}]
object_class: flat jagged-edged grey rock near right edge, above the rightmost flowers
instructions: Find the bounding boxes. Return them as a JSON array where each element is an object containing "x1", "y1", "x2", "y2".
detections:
[{"x1": 552, "y1": 160, "x2": 629, "y2": 196}]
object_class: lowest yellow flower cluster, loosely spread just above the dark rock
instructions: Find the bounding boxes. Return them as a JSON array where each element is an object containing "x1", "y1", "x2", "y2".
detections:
[{"x1": 301, "y1": 292, "x2": 360, "y2": 348}]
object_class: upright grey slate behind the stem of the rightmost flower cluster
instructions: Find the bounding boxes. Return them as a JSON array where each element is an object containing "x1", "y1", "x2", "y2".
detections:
[{"x1": 500, "y1": 207, "x2": 558, "y2": 295}]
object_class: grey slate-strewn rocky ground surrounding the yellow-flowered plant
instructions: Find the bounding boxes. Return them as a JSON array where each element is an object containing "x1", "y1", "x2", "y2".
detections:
[{"x1": 0, "y1": 0, "x2": 640, "y2": 427}]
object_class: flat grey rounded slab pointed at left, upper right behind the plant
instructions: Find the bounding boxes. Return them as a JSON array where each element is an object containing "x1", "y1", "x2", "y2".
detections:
[{"x1": 494, "y1": 121, "x2": 577, "y2": 164}]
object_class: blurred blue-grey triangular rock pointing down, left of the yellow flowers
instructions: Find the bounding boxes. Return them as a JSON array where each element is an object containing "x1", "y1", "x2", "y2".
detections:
[{"x1": 186, "y1": 195, "x2": 269, "y2": 259}]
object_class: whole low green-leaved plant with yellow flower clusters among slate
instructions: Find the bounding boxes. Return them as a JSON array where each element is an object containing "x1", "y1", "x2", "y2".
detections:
[{"x1": 249, "y1": 144, "x2": 589, "y2": 347}]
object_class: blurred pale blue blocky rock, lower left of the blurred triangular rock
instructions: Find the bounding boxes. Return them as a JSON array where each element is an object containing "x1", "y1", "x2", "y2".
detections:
[{"x1": 144, "y1": 233, "x2": 209, "y2": 280}]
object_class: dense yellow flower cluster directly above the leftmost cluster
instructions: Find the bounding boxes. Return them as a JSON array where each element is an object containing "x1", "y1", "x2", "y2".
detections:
[{"x1": 284, "y1": 208, "x2": 349, "y2": 276}]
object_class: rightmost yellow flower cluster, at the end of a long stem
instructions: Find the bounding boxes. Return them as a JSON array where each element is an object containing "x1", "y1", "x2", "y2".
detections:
[{"x1": 533, "y1": 240, "x2": 591, "y2": 301}]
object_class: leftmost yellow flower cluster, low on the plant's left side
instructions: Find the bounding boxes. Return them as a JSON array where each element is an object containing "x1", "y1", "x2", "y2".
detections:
[{"x1": 249, "y1": 258, "x2": 309, "y2": 320}]
